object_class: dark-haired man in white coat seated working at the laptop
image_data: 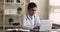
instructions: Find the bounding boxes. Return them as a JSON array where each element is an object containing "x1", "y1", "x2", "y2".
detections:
[{"x1": 23, "y1": 2, "x2": 41, "y2": 29}]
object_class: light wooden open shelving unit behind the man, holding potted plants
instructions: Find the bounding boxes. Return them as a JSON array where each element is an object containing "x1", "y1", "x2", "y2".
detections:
[{"x1": 0, "y1": 0, "x2": 28, "y2": 32}]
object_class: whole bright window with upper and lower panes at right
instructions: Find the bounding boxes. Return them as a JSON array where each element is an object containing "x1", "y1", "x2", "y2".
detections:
[{"x1": 49, "y1": 0, "x2": 60, "y2": 25}]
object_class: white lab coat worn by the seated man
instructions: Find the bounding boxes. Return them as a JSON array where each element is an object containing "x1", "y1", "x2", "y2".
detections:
[{"x1": 22, "y1": 14, "x2": 41, "y2": 29}]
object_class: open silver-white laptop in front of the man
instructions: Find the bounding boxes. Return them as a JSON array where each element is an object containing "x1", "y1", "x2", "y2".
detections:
[{"x1": 39, "y1": 20, "x2": 52, "y2": 31}]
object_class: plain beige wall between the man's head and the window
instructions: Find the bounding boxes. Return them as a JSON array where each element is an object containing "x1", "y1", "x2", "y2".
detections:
[{"x1": 30, "y1": 0, "x2": 49, "y2": 19}]
